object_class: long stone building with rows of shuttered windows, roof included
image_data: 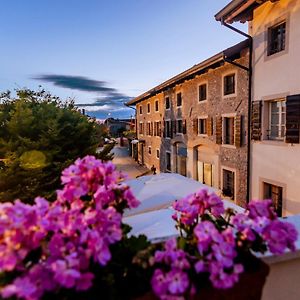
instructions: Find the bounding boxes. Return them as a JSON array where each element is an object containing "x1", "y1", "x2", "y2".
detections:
[{"x1": 127, "y1": 40, "x2": 249, "y2": 206}]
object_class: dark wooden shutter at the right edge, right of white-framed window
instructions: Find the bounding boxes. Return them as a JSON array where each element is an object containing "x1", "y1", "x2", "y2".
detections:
[{"x1": 285, "y1": 95, "x2": 300, "y2": 144}]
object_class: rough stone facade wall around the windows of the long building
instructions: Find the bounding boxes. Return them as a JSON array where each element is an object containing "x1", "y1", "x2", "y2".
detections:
[{"x1": 137, "y1": 53, "x2": 248, "y2": 206}]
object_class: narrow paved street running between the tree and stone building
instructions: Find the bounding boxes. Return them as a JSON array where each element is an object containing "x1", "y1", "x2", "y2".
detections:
[{"x1": 112, "y1": 145, "x2": 149, "y2": 179}]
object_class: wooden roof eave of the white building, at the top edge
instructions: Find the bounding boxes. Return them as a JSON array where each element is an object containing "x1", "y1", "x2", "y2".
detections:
[{"x1": 215, "y1": 0, "x2": 278, "y2": 23}]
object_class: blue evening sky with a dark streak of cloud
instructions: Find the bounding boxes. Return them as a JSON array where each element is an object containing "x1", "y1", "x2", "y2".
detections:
[{"x1": 0, "y1": 0, "x2": 247, "y2": 119}]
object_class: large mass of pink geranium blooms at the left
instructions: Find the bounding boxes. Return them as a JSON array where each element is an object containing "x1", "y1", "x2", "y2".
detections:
[{"x1": 0, "y1": 156, "x2": 139, "y2": 300}]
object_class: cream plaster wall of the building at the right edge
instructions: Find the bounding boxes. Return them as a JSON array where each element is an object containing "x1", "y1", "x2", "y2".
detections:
[{"x1": 249, "y1": 0, "x2": 300, "y2": 214}]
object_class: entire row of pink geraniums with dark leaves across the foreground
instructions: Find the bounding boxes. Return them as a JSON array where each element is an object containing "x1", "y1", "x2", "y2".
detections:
[{"x1": 0, "y1": 156, "x2": 297, "y2": 300}]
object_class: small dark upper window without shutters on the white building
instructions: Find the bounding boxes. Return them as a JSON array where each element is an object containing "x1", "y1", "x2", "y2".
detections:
[{"x1": 268, "y1": 22, "x2": 286, "y2": 55}]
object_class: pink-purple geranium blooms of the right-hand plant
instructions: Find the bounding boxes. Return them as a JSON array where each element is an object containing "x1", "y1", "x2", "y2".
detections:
[{"x1": 152, "y1": 190, "x2": 298, "y2": 299}]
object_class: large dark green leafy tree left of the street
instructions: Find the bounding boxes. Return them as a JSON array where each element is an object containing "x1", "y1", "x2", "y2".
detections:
[{"x1": 0, "y1": 89, "x2": 110, "y2": 203}]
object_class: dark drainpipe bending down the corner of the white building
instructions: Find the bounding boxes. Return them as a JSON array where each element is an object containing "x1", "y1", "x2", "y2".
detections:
[{"x1": 221, "y1": 19, "x2": 253, "y2": 203}]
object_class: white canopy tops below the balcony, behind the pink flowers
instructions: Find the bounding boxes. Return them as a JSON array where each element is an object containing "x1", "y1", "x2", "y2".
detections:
[{"x1": 124, "y1": 173, "x2": 243, "y2": 242}]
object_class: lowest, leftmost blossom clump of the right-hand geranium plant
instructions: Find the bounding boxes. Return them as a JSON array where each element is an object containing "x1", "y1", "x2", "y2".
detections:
[{"x1": 151, "y1": 239, "x2": 195, "y2": 300}]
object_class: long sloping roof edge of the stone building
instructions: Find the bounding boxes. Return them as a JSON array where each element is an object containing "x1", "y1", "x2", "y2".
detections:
[{"x1": 126, "y1": 40, "x2": 249, "y2": 106}]
